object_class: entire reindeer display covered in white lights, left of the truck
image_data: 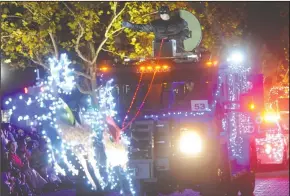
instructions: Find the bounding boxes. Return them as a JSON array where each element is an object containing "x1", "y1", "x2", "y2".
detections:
[{"x1": 5, "y1": 54, "x2": 135, "y2": 195}]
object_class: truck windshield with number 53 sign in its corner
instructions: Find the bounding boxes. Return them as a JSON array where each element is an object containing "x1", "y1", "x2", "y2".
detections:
[{"x1": 117, "y1": 81, "x2": 216, "y2": 113}]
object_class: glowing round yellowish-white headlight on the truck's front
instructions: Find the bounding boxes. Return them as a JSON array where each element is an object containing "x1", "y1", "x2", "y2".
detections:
[{"x1": 179, "y1": 131, "x2": 202, "y2": 155}]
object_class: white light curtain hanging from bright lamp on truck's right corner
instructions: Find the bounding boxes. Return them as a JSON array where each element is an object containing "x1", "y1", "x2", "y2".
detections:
[{"x1": 222, "y1": 57, "x2": 253, "y2": 160}]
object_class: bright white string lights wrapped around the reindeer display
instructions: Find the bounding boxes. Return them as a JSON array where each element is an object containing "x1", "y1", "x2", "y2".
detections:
[{"x1": 5, "y1": 54, "x2": 135, "y2": 195}]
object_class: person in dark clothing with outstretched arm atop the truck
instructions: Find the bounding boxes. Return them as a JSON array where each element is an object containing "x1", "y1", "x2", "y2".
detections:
[{"x1": 122, "y1": 6, "x2": 190, "y2": 53}]
